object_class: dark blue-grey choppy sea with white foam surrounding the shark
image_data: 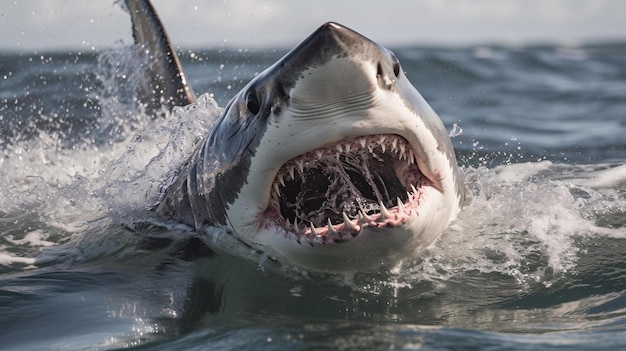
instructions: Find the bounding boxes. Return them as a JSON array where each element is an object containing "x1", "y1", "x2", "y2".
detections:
[{"x1": 0, "y1": 37, "x2": 626, "y2": 350}]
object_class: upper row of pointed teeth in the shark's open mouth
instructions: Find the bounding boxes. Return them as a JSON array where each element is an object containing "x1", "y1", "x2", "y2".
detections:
[{"x1": 274, "y1": 135, "x2": 416, "y2": 192}]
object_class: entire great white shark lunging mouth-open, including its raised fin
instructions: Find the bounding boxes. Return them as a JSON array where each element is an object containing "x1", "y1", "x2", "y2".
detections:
[{"x1": 126, "y1": 0, "x2": 466, "y2": 272}]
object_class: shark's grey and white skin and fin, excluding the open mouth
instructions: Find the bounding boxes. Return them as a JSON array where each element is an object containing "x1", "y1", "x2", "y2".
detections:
[{"x1": 127, "y1": 0, "x2": 466, "y2": 271}]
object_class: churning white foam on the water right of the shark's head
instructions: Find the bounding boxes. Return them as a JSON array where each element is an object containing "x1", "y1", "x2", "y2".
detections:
[{"x1": 394, "y1": 162, "x2": 626, "y2": 285}]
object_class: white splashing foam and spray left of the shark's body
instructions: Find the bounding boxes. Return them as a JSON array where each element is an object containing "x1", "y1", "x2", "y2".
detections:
[{"x1": 0, "y1": 48, "x2": 220, "y2": 265}]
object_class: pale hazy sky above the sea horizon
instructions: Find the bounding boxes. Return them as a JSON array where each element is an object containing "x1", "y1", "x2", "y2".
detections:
[{"x1": 0, "y1": 0, "x2": 626, "y2": 51}]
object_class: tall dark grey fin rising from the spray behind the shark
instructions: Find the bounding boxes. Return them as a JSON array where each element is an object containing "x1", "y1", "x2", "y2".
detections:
[{"x1": 126, "y1": 0, "x2": 196, "y2": 111}]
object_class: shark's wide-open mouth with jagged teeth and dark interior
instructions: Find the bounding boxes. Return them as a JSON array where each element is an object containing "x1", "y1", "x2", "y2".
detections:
[{"x1": 265, "y1": 134, "x2": 429, "y2": 243}]
